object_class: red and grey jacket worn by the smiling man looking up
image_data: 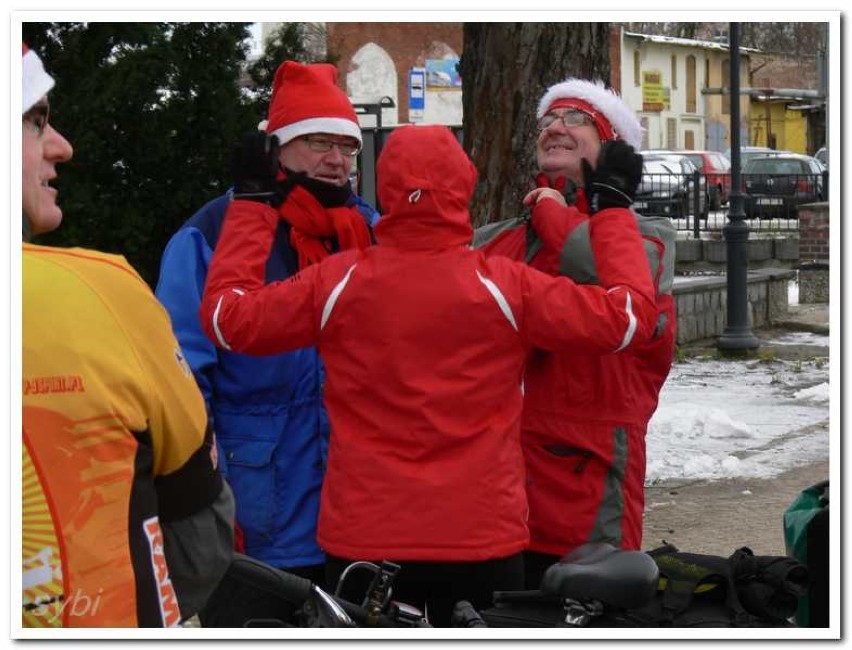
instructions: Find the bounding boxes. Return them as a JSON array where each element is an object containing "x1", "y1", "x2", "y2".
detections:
[{"x1": 476, "y1": 185, "x2": 677, "y2": 556}]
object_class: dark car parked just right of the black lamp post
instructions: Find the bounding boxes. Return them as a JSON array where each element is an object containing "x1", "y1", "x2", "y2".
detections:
[{"x1": 743, "y1": 153, "x2": 825, "y2": 219}]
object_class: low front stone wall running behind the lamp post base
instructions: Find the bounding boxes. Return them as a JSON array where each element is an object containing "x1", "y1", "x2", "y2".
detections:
[{"x1": 673, "y1": 268, "x2": 796, "y2": 345}]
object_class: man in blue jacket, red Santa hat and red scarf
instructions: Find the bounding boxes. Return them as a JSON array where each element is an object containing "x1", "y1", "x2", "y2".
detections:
[{"x1": 157, "y1": 61, "x2": 378, "y2": 626}]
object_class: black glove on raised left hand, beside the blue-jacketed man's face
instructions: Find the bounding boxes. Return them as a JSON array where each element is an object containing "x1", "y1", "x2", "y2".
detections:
[{"x1": 231, "y1": 131, "x2": 284, "y2": 208}]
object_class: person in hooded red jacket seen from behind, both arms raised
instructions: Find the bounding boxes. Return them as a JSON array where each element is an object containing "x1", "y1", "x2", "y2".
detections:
[{"x1": 201, "y1": 126, "x2": 656, "y2": 626}]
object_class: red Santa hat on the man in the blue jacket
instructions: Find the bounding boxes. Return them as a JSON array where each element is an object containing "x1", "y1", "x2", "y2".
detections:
[{"x1": 266, "y1": 61, "x2": 361, "y2": 144}]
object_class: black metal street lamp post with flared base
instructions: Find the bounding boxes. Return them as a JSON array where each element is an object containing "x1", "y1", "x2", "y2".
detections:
[{"x1": 716, "y1": 23, "x2": 760, "y2": 353}]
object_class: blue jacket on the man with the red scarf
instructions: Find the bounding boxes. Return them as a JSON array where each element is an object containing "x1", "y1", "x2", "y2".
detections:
[{"x1": 156, "y1": 194, "x2": 378, "y2": 567}]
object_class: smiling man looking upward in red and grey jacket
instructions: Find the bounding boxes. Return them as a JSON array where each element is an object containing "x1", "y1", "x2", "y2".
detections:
[{"x1": 474, "y1": 78, "x2": 676, "y2": 589}]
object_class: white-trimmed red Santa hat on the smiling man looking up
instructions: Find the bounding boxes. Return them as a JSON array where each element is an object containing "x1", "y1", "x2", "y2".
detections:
[{"x1": 536, "y1": 77, "x2": 642, "y2": 149}]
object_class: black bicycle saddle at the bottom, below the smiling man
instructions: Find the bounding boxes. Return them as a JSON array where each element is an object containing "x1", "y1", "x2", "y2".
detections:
[{"x1": 541, "y1": 542, "x2": 660, "y2": 609}]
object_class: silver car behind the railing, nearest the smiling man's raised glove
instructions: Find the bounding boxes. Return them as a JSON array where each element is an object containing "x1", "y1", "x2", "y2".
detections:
[{"x1": 633, "y1": 151, "x2": 709, "y2": 219}]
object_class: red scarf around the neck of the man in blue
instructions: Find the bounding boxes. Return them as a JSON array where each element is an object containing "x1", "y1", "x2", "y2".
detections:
[{"x1": 278, "y1": 185, "x2": 372, "y2": 270}]
